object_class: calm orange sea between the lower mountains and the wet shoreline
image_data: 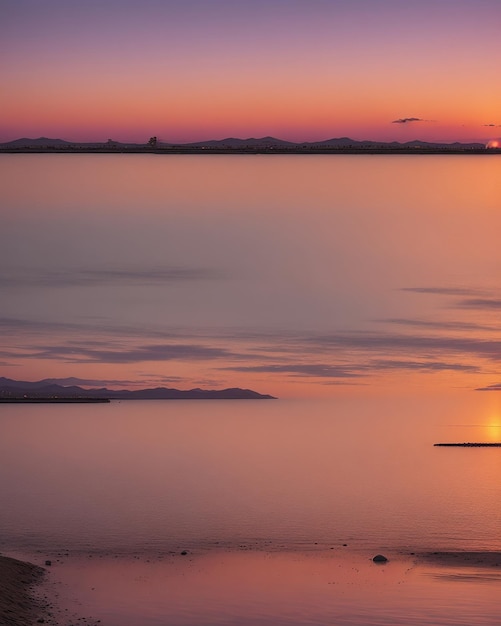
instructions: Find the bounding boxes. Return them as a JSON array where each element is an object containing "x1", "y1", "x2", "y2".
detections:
[{"x1": 0, "y1": 391, "x2": 501, "y2": 553}]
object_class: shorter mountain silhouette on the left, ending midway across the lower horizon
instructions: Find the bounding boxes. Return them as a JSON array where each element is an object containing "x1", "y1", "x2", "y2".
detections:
[{"x1": 0, "y1": 377, "x2": 274, "y2": 401}]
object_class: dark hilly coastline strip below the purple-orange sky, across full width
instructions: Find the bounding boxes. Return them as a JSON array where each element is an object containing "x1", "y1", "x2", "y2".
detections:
[{"x1": 0, "y1": 137, "x2": 501, "y2": 155}]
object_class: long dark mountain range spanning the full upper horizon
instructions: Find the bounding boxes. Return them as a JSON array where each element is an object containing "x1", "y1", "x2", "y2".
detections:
[{"x1": 0, "y1": 137, "x2": 492, "y2": 153}]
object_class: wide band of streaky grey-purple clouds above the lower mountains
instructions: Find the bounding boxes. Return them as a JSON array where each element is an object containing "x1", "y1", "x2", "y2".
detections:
[{"x1": 0, "y1": 306, "x2": 501, "y2": 384}]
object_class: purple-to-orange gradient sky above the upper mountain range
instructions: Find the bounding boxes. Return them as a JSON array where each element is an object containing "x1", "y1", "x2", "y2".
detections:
[{"x1": 0, "y1": 0, "x2": 501, "y2": 142}]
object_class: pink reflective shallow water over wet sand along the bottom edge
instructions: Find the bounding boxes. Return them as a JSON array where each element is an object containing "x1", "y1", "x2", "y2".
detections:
[{"x1": 46, "y1": 550, "x2": 500, "y2": 626}]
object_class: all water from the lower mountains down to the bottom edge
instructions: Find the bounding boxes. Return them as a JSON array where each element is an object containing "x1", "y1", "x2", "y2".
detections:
[{"x1": 0, "y1": 391, "x2": 501, "y2": 626}]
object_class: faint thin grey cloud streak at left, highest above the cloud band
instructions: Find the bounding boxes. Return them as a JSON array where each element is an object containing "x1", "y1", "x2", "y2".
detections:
[{"x1": 0, "y1": 267, "x2": 225, "y2": 288}]
